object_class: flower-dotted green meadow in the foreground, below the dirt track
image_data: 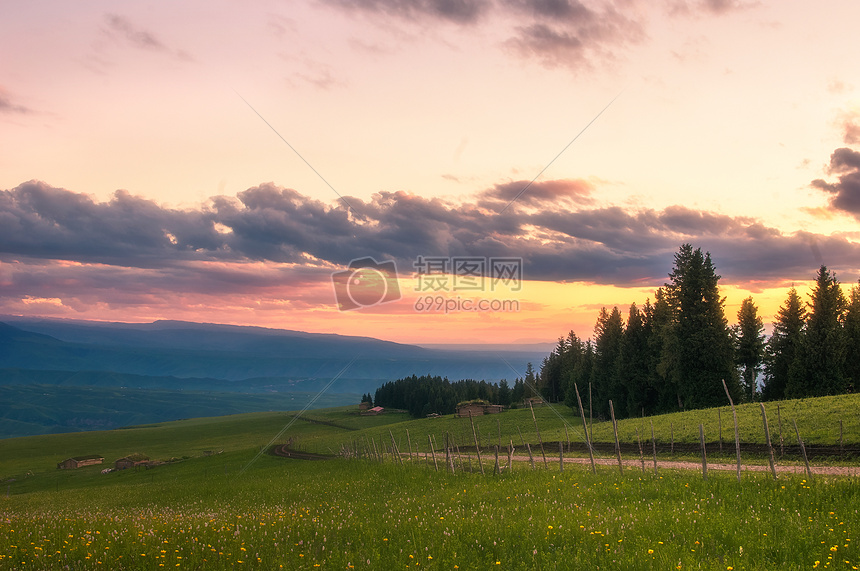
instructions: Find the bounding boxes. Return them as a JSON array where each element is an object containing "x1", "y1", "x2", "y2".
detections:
[{"x1": 0, "y1": 451, "x2": 860, "y2": 570}]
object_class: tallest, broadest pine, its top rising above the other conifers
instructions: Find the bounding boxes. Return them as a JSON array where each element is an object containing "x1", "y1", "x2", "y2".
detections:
[{"x1": 661, "y1": 244, "x2": 741, "y2": 409}]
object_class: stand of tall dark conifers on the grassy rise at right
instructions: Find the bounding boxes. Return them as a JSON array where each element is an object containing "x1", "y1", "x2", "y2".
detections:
[{"x1": 535, "y1": 244, "x2": 860, "y2": 418}]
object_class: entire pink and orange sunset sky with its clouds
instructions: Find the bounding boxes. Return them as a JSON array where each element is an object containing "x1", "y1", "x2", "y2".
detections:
[{"x1": 0, "y1": 0, "x2": 860, "y2": 343}]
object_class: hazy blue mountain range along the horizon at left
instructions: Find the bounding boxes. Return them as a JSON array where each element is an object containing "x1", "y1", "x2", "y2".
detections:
[{"x1": 0, "y1": 317, "x2": 547, "y2": 384}]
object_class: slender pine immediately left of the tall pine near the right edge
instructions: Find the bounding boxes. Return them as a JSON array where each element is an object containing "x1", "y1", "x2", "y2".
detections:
[{"x1": 762, "y1": 288, "x2": 806, "y2": 400}]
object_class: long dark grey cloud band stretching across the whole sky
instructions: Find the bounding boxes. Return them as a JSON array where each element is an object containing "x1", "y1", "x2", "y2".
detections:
[{"x1": 0, "y1": 178, "x2": 860, "y2": 290}]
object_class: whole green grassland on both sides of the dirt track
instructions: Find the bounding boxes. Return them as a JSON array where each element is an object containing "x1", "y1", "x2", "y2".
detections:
[{"x1": 0, "y1": 396, "x2": 860, "y2": 569}]
